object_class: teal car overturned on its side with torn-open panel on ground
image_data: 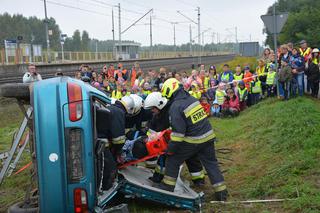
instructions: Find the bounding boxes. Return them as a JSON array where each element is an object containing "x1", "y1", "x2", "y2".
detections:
[{"x1": 0, "y1": 77, "x2": 202, "y2": 213}]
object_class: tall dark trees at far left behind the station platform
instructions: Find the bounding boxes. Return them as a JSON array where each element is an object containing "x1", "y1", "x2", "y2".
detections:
[{"x1": 0, "y1": 13, "x2": 132, "y2": 52}]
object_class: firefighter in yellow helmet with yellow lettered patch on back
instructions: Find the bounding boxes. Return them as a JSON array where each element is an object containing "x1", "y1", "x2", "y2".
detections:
[{"x1": 159, "y1": 78, "x2": 228, "y2": 201}]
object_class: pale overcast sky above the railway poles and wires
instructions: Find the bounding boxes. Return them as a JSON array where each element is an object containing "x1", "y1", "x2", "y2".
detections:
[{"x1": 0, "y1": 0, "x2": 275, "y2": 45}]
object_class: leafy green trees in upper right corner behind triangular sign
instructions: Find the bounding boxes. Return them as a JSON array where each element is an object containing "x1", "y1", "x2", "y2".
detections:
[{"x1": 266, "y1": 0, "x2": 320, "y2": 48}]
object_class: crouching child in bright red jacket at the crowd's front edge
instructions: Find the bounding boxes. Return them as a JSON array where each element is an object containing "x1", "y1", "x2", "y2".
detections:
[{"x1": 221, "y1": 88, "x2": 240, "y2": 117}]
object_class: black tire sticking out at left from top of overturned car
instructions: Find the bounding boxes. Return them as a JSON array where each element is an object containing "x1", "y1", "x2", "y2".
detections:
[{"x1": 0, "y1": 83, "x2": 30, "y2": 100}]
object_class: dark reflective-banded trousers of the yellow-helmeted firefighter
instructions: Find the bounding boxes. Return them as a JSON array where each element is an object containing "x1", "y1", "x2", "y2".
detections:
[{"x1": 163, "y1": 140, "x2": 225, "y2": 191}]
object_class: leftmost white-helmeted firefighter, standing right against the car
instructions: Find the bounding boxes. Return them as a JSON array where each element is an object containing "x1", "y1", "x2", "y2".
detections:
[{"x1": 95, "y1": 96, "x2": 134, "y2": 190}]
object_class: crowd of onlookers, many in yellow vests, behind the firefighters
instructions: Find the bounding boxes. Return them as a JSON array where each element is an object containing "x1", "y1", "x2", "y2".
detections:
[{"x1": 68, "y1": 40, "x2": 320, "y2": 117}]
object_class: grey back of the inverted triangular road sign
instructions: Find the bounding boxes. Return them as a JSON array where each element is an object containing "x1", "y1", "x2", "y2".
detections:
[{"x1": 261, "y1": 13, "x2": 289, "y2": 34}]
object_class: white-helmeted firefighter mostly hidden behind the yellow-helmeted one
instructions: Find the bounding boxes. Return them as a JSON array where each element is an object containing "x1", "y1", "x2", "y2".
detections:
[{"x1": 144, "y1": 92, "x2": 205, "y2": 186}]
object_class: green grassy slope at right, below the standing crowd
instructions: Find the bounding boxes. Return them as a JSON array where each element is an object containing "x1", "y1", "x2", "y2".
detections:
[{"x1": 211, "y1": 98, "x2": 320, "y2": 212}]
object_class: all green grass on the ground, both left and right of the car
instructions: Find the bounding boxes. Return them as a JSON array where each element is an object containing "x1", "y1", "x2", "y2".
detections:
[{"x1": 0, "y1": 97, "x2": 320, "y2": 212}]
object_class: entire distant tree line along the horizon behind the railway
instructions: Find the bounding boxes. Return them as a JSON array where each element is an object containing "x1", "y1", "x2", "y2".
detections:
[{"x1": 0, "y1": 13, "x2": 234, "y2": 52}]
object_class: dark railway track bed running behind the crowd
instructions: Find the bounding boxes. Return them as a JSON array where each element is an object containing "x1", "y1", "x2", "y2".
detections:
[{"x1": 0, "y1": 55, "x2": 234, "y2": 84}]
